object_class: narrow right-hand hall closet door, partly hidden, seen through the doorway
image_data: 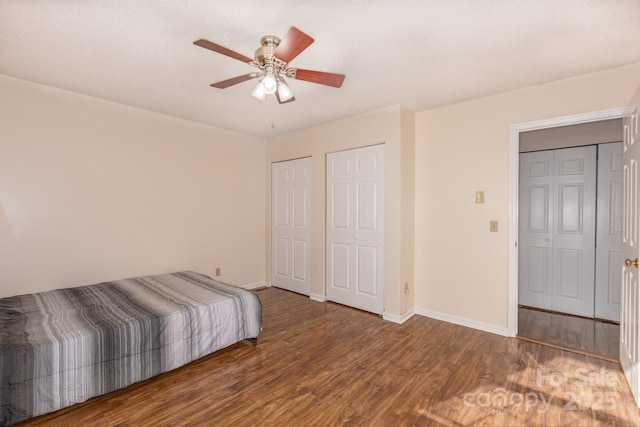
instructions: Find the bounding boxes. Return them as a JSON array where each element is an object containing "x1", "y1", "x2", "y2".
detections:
[{"x1": 595, "y1": 142, "x2": 622, "y2": 322}]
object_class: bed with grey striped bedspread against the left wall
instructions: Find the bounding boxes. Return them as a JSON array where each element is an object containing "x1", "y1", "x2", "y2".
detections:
[{"x1": 0, "y1": 271, "x2": 262, "y2": 425}]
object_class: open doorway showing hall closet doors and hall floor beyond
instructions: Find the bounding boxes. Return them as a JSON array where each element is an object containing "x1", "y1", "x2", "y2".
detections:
[{"x1": 517, "y1": 120, "x2": 622, "y2": 360}]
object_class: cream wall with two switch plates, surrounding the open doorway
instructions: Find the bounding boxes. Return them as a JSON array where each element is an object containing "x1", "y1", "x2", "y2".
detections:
[{"x1": 415, "y1": 64, "x2": 640, "y2": 333}]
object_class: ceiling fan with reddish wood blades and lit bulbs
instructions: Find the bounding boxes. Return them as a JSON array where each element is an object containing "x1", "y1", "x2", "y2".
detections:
[{"x1": 193, "y1": 27, "x2": 345, "y2": 104}]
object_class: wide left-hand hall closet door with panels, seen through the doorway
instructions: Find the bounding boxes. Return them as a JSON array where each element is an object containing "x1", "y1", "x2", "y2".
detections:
[{"x1": 518, "y1": 146, "x2": 596, "y2": 317}]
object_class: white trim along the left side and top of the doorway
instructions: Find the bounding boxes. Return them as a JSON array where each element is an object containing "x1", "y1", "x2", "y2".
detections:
[{"x1": 507, "y1": 106, "x2": 632, "y2": 337}]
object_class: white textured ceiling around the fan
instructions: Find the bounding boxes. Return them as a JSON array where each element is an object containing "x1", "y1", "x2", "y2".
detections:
[{"x1": 0, "y1": 0, "x2": 640, "y2": 138}]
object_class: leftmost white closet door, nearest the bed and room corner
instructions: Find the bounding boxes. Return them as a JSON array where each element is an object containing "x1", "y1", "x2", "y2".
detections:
[{"x1": 271, "y1": 157, "x2": 311, "y2": 295}]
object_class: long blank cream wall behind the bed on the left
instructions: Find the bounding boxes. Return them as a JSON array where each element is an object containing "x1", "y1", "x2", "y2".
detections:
[{"x1": 0, "y1": 76, "x2": 266, "y2": 297}]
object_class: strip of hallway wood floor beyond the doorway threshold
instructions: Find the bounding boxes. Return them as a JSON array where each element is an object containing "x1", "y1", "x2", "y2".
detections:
[{"x1": 518, "y1": 307, "x2": 620, "y2": 362}]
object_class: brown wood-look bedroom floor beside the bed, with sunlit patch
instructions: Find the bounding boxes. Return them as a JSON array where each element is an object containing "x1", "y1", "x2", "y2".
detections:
[{"x1": 17, "y1": 288, "x2": 640, "y2": 426}]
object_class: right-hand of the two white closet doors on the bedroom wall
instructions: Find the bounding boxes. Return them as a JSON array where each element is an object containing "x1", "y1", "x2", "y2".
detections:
[{"x1": 326, "y1": 145, "x2": 384, "y2": 314}]
